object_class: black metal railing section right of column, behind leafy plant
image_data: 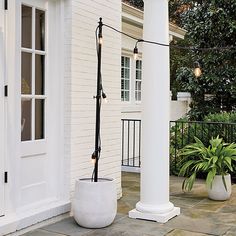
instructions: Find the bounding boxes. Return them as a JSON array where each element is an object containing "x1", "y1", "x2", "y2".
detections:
[{"x1": 170, "y1": 121, "x2": 236, "y2": 174}]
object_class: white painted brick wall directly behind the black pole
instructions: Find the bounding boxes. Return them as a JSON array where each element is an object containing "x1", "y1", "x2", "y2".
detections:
[{"x1": 65, "y1": 0, "x2": 121, "y2": 197}]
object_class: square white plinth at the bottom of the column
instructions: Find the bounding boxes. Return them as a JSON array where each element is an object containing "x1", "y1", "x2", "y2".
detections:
[{"x1": 129, "y1": 207, "x2": 180, "y2": 223}]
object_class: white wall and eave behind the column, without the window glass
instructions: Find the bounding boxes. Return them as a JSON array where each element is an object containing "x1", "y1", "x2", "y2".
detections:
[{"x1": 121, "y1": 4, "x2": 190, "y2": 120}]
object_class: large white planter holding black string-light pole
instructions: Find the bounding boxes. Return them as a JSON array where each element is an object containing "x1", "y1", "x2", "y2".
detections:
[{"x1": 73, "y1": 18, "x2": 117, "y2": 228}]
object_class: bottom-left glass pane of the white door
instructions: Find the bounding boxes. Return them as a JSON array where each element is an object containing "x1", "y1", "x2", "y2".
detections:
[{"x1": 21, "y1": 99, "x2": 32, "y2": 141}]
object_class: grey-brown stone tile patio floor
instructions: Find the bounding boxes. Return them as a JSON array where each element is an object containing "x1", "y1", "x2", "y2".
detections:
[{"x1": 21, "y1": 172, "x2": 236, "y2": 236}]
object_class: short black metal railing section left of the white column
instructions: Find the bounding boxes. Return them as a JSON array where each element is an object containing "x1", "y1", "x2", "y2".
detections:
[{"x1": 121, "y1": 119, "x2": 141, "y2": 167}]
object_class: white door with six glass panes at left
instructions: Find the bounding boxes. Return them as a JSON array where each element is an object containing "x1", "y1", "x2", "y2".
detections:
[{"x1": 16, "y1": 0, "x2": 64, "y2": 207}]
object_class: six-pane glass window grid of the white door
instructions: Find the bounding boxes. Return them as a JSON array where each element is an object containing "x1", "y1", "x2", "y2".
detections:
[{"x1": 21, "y1": 5, "x2": 46, "y2": 141}]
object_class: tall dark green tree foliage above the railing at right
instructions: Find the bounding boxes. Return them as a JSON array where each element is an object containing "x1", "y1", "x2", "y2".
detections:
[{"x1": 172, "y1": 0, "x2": 236, "y2": 120}]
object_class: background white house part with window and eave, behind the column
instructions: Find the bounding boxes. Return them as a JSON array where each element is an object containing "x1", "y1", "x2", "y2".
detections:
[{"x1": 121, "y1": 4, "x2": 187, "y2": 120}]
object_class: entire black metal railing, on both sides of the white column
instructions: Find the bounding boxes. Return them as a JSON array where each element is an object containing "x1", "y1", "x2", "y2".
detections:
[{"x1": 121, "y1": 119, "x2": 236, "y2": 174}]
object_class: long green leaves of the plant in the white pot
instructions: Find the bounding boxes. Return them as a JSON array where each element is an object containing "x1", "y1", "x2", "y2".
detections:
[{"x1": 179, "y1": 136, "x2": 236, "y2": 191}]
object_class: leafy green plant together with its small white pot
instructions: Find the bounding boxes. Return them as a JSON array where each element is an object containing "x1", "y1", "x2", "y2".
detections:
[{"x1": 179, "y1": 136, "x2": 236, "y2": 200}]
